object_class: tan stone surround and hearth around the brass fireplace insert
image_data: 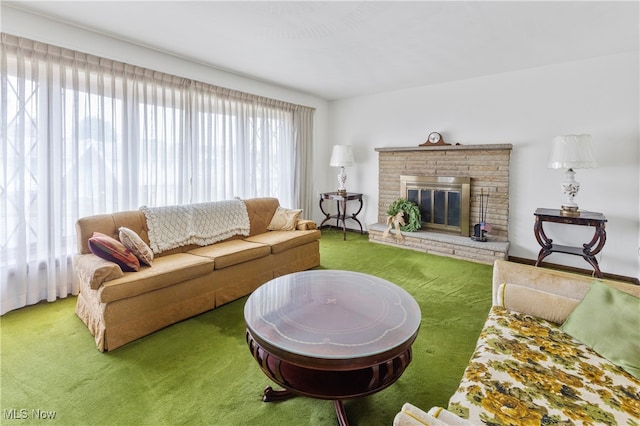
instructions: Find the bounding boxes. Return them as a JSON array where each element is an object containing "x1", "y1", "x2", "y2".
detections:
[{"x1": 369, "y1": 144, "x2": 512, "y2": 263}]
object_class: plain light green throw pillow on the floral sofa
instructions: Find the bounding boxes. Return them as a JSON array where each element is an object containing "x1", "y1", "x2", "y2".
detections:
[{"x1": 561, "y1": 280, "x2": 640, "y2": 379}]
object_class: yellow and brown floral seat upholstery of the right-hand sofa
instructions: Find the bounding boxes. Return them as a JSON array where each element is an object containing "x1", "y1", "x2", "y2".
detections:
[{"x1": 448, "y1": 306, "x2": 640, "y2": 425}]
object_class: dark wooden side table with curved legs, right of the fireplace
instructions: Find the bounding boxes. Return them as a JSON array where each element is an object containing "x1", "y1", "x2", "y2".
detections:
[{"x1": 533, "y1": 208, "x2": 607, "y2": 278}]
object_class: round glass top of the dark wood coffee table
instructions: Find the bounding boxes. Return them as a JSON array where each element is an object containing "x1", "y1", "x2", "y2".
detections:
[{"x1": 244, "y1": 270, "x2": 421, "y2": 359}]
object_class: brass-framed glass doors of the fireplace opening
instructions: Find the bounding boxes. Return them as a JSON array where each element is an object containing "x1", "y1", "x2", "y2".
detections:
[{"x1": 400, "y1": 176, "x2": 471, "y2": 237}]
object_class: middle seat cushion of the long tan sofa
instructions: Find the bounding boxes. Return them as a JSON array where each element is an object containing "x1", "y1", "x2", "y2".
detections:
[{"x1": 188, "y1": 240, "x2": 271, "y2": 269}]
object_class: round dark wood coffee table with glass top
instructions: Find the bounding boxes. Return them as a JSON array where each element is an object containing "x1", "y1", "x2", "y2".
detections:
[{"x1": 244, "y1": 270, "x2": 421, "y2": 425}]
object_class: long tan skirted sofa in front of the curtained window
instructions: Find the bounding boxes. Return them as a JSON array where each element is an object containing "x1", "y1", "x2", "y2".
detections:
[{"x1": 74, "y1": 198, "x2": 320, "y2": 351}]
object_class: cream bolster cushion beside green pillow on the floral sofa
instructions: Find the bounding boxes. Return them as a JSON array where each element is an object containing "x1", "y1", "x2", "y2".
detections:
[{"x1": 498, "y1": 283, "x2": 580, "y2": 324}]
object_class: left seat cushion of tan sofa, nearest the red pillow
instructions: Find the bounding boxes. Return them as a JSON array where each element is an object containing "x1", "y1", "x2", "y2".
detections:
[{"x1": 99, "y1": 253, "x2": 214, "y2": 303}]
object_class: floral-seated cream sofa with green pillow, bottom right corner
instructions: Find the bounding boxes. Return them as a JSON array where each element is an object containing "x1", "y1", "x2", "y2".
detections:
[{"x1": 394, "y1": 260, "x2": 640, "y2": 426}]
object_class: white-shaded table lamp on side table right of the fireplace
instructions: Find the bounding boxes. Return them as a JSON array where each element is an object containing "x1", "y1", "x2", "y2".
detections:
[{"x1": 549, "y1": 135, "x2": 598, "y2": 216}]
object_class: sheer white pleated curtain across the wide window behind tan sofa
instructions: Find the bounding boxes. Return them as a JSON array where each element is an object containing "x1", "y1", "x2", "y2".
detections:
[{"x1": 0, "y1": 34, "x2": 313, "y2": 314}]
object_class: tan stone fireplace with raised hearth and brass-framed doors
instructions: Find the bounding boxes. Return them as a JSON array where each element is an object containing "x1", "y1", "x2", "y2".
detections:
[{"x1": 368, "y1": 144, "x2": 512, "y2": 263}]
